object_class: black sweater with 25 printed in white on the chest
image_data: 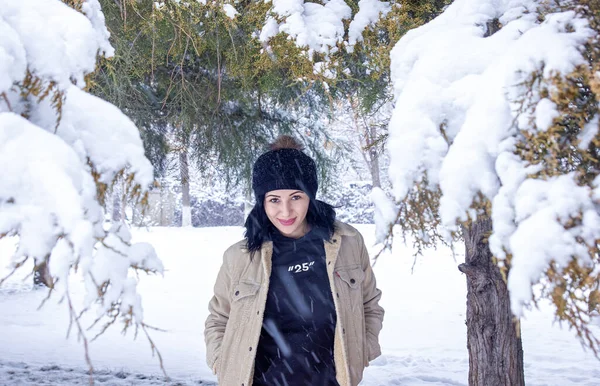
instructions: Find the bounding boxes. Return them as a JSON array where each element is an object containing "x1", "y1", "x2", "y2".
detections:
[{"x1": 253, "y1": 230, "x2": 338, "y2": 386}]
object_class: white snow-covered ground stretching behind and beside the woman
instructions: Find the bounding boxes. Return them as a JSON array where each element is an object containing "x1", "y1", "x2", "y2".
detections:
[{"x1": 0, "y1": 225, "x2": 600, "y2": 386}]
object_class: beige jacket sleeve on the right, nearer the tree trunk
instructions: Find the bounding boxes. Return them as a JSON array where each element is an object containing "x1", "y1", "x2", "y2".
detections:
[{"x1": 360, "y1": 236, "x2": 384, "y2": 362}]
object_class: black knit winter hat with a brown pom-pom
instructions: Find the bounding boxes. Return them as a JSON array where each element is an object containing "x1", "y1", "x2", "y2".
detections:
[{"x1": 252, "y1": 135, "x2": 319, "y2": 200}]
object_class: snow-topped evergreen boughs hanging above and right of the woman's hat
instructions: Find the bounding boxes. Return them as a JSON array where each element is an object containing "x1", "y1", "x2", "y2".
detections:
[{"x1": 246, "y1": 0, "x2": 449, "y2": 191}]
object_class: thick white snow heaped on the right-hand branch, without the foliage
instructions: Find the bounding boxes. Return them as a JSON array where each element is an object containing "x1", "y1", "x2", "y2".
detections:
[{"x1": 379, "y1": 0, "x2": 600, "y2": 316}]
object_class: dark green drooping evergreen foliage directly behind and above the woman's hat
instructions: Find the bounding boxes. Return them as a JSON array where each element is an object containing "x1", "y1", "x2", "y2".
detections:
[{"x1": 92, "y1": 0, "x2": 338, "y2": 223}]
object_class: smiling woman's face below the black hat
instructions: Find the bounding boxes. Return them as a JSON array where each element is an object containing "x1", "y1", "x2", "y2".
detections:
[{"x1": 265, "y1": 189, "x2": 310, "y2": 238}]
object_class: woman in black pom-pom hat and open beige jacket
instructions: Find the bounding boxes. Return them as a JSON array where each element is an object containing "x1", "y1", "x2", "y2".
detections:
[{"x1": 204, "y1": 136, "x2": 383, "y2": 386}]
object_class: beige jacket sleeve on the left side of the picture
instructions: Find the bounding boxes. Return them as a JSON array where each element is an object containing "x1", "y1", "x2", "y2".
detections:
[{"x1": 204, "y1": 250, "x2": 231, "y2": 374}]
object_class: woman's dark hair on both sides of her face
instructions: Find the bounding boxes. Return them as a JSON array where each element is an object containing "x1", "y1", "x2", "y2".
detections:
[{"x1": 244, "y1": 196, "x2": 335, "y2": 259}]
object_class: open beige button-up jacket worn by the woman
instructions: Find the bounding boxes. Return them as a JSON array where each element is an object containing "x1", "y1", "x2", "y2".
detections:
[{"x1": 204, "y1": 222, "x2": 384, "y2": 386}]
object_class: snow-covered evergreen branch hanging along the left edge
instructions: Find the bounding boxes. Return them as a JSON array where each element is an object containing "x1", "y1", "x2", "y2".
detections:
[{"x1": 0, "y1": 0, "x2": 163, "y2": 374}]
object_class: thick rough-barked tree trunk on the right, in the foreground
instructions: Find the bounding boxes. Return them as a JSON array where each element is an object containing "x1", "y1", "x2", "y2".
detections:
[{"x1": 458, "y1": 217, "x2": 525, "y2": 386}]
